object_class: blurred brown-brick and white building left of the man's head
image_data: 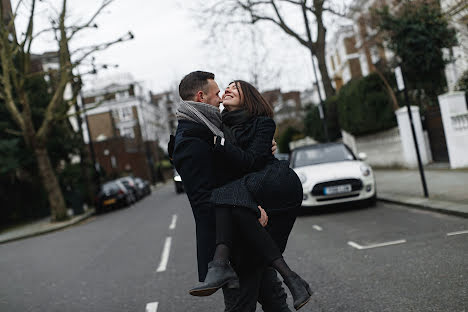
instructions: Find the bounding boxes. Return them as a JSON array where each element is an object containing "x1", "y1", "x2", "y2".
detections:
[{"x1": 82, "y1": 80, "x2": 159, "y2": 182}]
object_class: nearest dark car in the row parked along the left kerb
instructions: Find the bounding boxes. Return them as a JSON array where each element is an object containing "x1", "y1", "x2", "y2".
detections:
[{"x1": 96, "y1": 180, "x2": 135, "y2": 213}]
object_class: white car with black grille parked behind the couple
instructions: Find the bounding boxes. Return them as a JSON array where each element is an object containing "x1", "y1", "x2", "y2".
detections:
[{"x1": 291, "y1": 143, "x2": 377, "y2": 207}]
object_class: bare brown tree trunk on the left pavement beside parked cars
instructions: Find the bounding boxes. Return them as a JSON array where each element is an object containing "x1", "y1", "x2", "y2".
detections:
[{"x1": 34, "y1": 144, "x2": 68, "y2": 222}]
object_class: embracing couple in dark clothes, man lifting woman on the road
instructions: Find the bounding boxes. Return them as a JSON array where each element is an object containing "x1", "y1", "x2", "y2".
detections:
[{"x1": 169, "y1": 71, "x2": 312, "y2": 312}]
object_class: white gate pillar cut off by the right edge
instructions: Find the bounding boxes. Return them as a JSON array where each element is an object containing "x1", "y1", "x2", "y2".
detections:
[{"x1": 439, "y1": 92, "x2": 468, "y2": 168}]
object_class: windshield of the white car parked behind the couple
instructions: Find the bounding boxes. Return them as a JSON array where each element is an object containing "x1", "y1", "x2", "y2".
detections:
[{"x1": 293, "y1": 144, "x2": 356, "y2": 168}]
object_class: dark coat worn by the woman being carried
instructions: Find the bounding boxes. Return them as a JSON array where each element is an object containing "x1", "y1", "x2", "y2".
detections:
[{"x1": 211, "y1": 116, "x2": 303, "y2": 214}]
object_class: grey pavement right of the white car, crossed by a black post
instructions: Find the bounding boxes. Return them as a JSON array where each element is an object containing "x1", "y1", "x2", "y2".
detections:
[{"x1": 374, "y1": 165, "x2": 468, "y2": 217}]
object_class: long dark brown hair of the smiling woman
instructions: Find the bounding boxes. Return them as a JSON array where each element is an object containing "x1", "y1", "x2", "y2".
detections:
[{"x1": 231, "y1": 80, "x2": 273, "y2": 118}]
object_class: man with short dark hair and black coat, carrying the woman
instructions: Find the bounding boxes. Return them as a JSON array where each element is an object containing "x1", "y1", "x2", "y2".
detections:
[{"x1": 173, "y1": 71, "x2": 290, "y2": 312}]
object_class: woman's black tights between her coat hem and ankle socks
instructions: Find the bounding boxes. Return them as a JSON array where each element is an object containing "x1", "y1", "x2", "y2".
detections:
[{"x1": 216, "y1": 206, "x2": 282, "y2": 265}]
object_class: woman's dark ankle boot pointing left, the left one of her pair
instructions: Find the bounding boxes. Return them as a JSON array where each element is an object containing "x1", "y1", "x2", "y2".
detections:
[{"x1": 189, "y1": 260, "x2": 239, "y2": 296}]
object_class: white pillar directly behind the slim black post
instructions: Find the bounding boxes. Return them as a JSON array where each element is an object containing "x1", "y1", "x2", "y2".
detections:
[{"x1": 395, "y1": 106, "x2": 429, "y2": 168}]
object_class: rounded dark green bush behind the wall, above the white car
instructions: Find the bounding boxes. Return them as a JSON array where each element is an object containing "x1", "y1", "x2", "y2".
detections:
[{"x1": 338, "y1": 74, "x2": 397, "y2": 135}]
